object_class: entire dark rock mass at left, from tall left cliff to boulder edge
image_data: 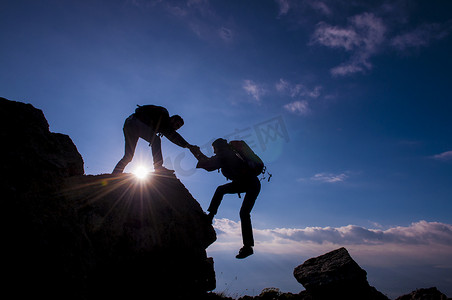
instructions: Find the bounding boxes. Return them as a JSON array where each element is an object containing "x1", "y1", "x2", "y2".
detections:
[{"x1": 0, "y1": 98, "x2": 216, "y2": 299}]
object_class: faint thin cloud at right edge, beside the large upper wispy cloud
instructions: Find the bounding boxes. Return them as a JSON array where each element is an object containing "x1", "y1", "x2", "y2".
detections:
[{"x1": 390, "y1": 21, "x2": 452, "y2": 51}]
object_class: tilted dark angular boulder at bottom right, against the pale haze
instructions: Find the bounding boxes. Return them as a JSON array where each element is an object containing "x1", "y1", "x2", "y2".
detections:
[{"x1": 294, "y1": 248, "x2": 388, "y2": 300}]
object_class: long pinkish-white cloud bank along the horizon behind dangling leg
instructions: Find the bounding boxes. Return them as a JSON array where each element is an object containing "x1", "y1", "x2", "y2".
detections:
[{"x1": 209, "y1": 219, "x2": 452, "y2": 267}]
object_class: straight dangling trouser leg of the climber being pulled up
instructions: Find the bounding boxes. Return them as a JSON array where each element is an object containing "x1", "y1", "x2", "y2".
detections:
[{"x1": 240, "y1": 177, "x2": 261, "y2": 246}]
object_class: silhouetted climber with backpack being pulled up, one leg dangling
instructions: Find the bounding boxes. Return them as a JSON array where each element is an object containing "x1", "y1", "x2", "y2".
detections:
[{"x1": 192, "y1": 138, "x2": 263, "y2": 258}]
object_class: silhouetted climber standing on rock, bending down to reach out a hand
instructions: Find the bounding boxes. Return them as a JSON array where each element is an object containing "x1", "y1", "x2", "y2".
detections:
[{"x1": 113, "y1": 105, "x2": 197, "y2": 174}]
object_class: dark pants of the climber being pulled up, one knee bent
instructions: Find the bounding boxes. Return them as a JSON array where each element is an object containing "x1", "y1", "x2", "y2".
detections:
[{"x1": 207, "y1": 177, "x2": 261, "y2": 246}]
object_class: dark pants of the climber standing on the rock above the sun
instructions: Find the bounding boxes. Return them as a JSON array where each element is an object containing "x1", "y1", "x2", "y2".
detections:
[{"x1": 113, "y1": 114, "x2": 163, "y2": 173}]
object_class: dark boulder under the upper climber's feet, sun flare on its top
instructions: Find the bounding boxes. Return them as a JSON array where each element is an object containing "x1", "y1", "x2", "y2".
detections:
[{"x1": 61, "y1": 174, "x2": 216, "y2": 299}]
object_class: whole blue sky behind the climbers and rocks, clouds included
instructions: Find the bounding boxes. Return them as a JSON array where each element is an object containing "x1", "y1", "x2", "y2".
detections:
[{"x1": 0, "y1": 0, "x2": 452, "y2": 298}]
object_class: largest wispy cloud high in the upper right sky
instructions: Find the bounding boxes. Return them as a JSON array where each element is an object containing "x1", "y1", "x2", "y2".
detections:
[{"x1": 310, "y1": 12, "x2": 386, "y2": 76}]
